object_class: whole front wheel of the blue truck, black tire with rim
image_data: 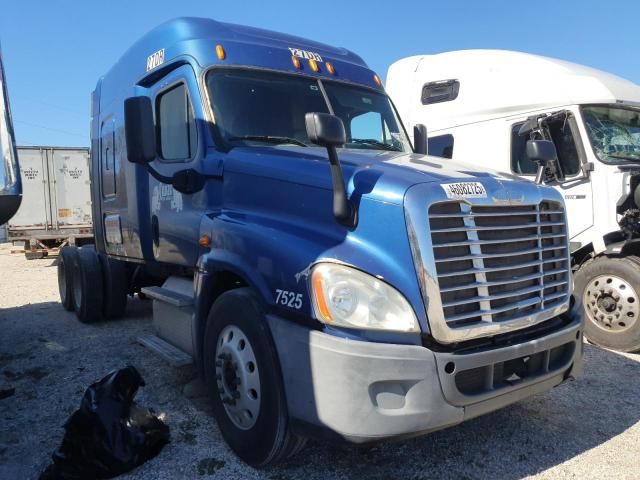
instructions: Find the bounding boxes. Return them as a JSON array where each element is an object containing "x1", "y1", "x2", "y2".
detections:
[{"x1": 204, "y1": 288, "x2": 304, "y2": 467}]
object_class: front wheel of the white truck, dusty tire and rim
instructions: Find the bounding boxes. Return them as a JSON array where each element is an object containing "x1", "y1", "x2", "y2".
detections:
[{"x1": 574, "y1": 257, "x2": 640, "y2": 352}]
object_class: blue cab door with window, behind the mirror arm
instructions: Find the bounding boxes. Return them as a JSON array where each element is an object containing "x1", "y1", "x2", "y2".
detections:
[{"x1": 148, "y1": 65, "x2": 208, "y2": 266}]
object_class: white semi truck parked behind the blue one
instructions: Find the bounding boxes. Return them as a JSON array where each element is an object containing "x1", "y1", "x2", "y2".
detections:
[{"x1": 386, "y1": 50, "x2": 640, "y2": 351}]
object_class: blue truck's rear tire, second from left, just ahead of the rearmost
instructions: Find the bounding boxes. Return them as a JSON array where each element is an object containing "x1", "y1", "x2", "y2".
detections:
[{"x1": 73, "y1": 248, "x2": 103, "y2": 323}]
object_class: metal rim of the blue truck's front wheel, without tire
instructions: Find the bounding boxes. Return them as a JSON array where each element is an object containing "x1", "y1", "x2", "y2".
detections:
[{"x1": 215, "y1": 325, "x2": 262, "y2": 430}]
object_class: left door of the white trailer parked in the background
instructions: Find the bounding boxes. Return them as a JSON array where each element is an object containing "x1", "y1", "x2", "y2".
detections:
[{"x1": 9, "y1": 148, "x2": 51, "y2": 234}]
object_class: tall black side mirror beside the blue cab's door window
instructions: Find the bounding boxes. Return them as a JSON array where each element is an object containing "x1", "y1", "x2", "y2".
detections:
[{"x1": 124, "y1": 97, "x2": 156, "y2": 165}]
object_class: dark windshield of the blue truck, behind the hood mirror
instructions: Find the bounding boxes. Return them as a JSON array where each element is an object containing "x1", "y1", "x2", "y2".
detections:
[{"x1": 206, "y1": 68, "x2": 411, "y2": 152}]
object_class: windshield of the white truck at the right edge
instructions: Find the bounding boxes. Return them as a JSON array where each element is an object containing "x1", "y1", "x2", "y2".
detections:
[{"x1": 582, "y1": 106, "x2": 640, "y2": 164}]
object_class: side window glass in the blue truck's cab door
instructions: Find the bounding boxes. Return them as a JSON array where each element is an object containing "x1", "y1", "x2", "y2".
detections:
[{"x1": 156, "y1": 83, "x2": 197, "y2": 162}]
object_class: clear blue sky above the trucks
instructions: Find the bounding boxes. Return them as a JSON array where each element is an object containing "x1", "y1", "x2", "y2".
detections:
[{"x1": 0, "y1": 0, "x2": 640, "y2": 146}]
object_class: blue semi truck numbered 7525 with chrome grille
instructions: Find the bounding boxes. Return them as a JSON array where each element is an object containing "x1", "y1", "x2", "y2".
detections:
[{"x1": 58, "y1": 18, "x2": 582, "y2": 466}]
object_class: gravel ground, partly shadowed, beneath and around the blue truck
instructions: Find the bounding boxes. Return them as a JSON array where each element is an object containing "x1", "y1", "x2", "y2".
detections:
[{"x1": 0, "y1": 245, "x2": 640, "y2": 480}]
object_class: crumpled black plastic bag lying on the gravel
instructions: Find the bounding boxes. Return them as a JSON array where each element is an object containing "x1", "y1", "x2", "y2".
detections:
[{"x1": 40, "y1": 366, "x2": 169, "y2": 480}]
